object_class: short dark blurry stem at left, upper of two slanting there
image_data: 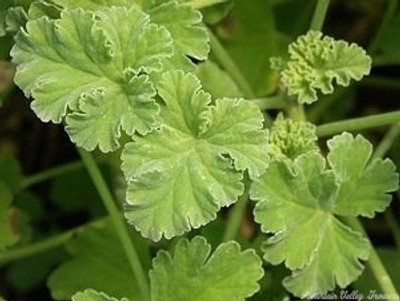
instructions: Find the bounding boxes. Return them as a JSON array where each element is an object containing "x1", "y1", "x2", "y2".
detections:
[{"x1": 19, "y1": 161, "x2": 84, "y2": 190}]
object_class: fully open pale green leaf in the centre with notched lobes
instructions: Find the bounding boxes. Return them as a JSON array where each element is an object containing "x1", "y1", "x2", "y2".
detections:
[{"x1": 122, "y1": 71, "x2": 268, "y2": 240}]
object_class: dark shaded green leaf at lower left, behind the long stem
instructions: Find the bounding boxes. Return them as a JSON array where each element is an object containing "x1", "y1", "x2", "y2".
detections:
[{"x1": 47, "y1": 223, "x2": 150, "y2": 301}]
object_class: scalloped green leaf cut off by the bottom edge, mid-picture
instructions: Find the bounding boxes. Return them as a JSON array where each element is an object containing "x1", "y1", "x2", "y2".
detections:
[{"x1": 150, "y1": 236, "x2": 264, "y2": 301}]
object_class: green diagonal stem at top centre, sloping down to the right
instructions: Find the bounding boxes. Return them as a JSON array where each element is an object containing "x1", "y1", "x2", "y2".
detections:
[{"x1": 208, "y1": 30, "x2": 255, "y2": 98}]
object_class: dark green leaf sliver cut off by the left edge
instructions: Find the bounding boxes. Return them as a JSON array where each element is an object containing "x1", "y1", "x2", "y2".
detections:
[{"x1": 0, "y1": 182, "x2": 19, "y2": 251}]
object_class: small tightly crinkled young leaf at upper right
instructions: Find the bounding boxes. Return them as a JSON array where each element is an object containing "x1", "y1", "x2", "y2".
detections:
[{"x1": 275, "y1": 31, "x2": 371, "y2": 104}]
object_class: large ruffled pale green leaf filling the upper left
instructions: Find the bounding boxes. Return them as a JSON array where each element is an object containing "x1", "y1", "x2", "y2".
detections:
[{"x1": 12, "y1": 7, "x2": 173, "y2": 152}]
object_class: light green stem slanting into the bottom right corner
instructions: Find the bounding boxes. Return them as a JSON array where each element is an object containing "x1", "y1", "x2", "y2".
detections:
[{"x1": 345, "y1": 217, "x2": 399, "y2": 301}]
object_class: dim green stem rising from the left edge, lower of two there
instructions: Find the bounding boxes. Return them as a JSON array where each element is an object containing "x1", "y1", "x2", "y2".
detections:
[{"x1": 0, "y1": 217, "x2": 108, "y2": 266}]
